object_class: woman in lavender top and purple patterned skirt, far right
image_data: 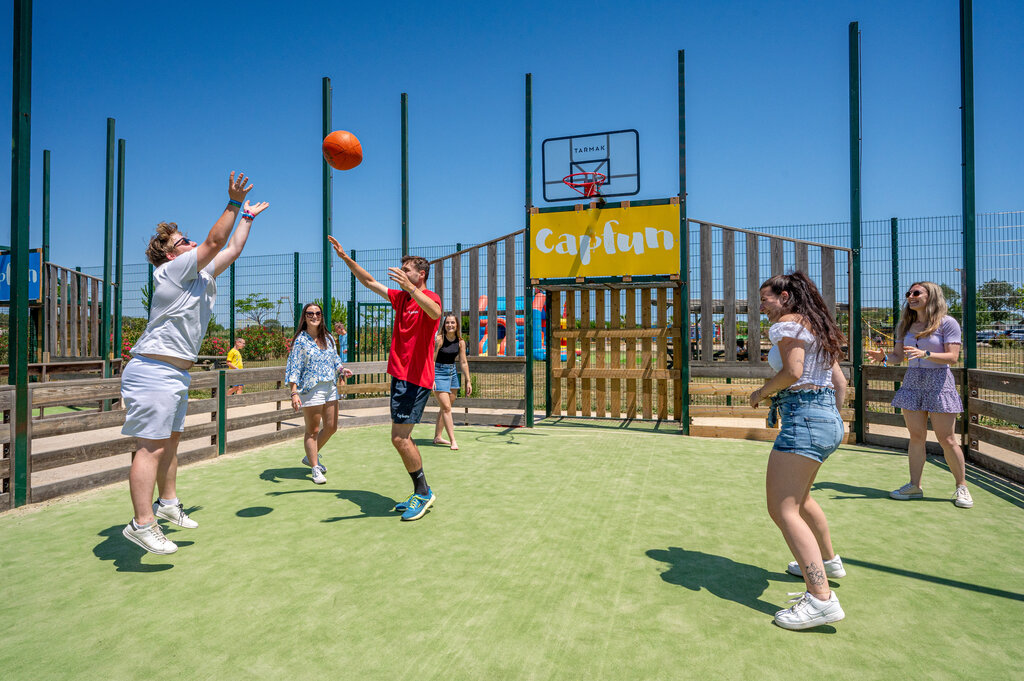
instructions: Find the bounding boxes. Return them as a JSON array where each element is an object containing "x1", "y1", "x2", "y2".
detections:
[{"x1": 867, "y1": 282, "x2": 974, "y2": 508}]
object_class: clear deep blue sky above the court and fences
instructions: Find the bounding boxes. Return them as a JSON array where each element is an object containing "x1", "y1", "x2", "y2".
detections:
[{"x1": 0, "y1": 0, "x2": 1024, "y2": 266}]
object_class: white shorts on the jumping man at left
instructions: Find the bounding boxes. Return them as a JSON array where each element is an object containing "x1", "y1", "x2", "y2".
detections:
[{"x1": 121, "y1": 356, "x2": 191, "y2": 439}]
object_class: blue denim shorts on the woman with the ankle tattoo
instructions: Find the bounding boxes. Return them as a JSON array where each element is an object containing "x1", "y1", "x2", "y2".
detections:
[{"x1": 772, "y1": 388, "x2": 843, "y2": 462}]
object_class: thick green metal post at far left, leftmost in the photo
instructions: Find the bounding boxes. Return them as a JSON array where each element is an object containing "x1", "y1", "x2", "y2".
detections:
[{"x1": 7, "y1": 0, "x2": 32, "y2": 506}]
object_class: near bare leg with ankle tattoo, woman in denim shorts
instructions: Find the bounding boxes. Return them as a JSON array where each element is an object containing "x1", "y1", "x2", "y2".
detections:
[{"x1": 765, "y1": 450, "x2": 831, "y2": 600}]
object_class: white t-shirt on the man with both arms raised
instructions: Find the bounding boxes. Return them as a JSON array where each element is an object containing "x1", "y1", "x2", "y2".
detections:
[{"x1": 131, "y1": 249, "x2": 217, "y2": 361}]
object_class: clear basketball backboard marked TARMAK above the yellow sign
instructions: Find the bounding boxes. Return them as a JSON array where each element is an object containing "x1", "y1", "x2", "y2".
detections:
[{"x1": 541, "y1": 130, "x2": 640, "y2": 202}]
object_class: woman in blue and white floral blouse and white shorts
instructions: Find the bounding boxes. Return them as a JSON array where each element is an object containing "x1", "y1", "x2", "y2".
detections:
[{"x1": 285, "y1": 303, "x2": 352, "y2": 484}]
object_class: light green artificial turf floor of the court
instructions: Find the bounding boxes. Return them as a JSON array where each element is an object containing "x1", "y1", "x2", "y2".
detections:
[{"x1": 0, "y1": 425, "x2": 1024, "y2": 681}]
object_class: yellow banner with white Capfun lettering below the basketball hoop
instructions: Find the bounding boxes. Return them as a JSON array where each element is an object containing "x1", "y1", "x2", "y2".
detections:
[{"x1": 529, "y1": 204, "x2": 679, "y2": 279}]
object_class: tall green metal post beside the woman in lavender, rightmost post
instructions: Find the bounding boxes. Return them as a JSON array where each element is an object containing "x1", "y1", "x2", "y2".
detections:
[{"x1": 961, "y1": 0, "x2": 978, "y2": 372}]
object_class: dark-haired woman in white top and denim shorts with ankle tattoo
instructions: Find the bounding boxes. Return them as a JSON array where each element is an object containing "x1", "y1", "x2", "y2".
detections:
[{"x1": 750, "y1": 271, "x2": 847, "y2": 629}]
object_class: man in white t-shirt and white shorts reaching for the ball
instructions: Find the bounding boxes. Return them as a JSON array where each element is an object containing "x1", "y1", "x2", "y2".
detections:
[{"x1": 121, "y1": 172, "x2": 269, "y2": 554}]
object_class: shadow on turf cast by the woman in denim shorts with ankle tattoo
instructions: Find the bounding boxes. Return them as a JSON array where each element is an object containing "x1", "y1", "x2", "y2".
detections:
[{"x1": 646, "y1": 546, "x2": 845, "y2": 634}]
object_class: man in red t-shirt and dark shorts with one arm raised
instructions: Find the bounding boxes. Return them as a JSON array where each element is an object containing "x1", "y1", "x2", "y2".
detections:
[{"x1": 328, "y1": 237, "x2": 441, "y2": 520}]
